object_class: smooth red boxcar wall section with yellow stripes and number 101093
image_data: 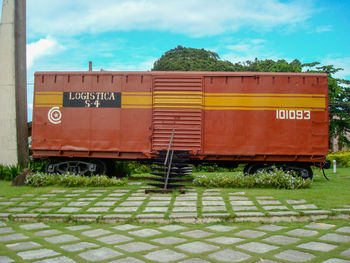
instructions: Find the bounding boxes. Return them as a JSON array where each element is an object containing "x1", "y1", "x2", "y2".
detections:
[{"x1": 204, "y1": 76, "x2": 328, "y2": 161}]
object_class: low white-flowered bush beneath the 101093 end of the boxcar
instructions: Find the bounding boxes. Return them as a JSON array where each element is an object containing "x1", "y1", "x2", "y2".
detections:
[{"x1": 193, "y1": 169, "x2": 312, "y2": 189}]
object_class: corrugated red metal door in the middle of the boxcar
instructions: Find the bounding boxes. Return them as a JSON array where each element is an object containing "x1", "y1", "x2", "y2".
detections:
[{"x1": 152, "y1": 76, "x2": 203, "y2": 153}]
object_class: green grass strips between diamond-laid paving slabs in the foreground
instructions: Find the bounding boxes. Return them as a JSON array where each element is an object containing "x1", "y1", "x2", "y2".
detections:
[{"x1": 0, "y1": 220, "x2": 349, "y2": 263}]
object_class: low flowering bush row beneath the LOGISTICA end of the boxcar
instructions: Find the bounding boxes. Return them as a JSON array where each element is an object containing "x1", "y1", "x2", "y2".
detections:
[{"x1": 26, "y1": 172, "x2": 128, "y2": 187}]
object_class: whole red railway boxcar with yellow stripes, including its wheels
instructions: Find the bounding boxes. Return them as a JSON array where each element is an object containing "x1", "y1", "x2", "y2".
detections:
[{"x1": 31, "y1": 72, "x2": 328, "y2": 177}]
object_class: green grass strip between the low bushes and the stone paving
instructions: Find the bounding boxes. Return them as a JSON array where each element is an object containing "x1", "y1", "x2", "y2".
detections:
[{"x1": 0, "y1": 168, "x2": 350, "y2": 214}]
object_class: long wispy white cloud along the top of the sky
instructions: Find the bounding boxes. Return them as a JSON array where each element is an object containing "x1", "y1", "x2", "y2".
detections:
[{"x1": 28, "y1": 0, "x2": 313, "y2": 36}]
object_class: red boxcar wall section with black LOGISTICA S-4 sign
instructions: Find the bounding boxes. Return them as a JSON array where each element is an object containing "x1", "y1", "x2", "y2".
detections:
[{"x1": 32, "y1": 74, "x2": 152, "y2": 158}]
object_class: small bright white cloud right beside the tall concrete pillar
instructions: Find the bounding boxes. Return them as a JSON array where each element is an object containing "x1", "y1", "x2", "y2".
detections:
[{"x1": 27, "y1": 38, "x2": 63, "y2": 68}]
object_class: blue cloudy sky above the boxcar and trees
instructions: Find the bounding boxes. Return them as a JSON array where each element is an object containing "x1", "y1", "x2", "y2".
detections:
[{"x1": 0, "y1": 0, "x2": 350, "y2": 120}]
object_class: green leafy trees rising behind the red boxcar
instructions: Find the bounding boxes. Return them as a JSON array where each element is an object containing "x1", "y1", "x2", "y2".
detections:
[{"x1": 152, "y1": 46, "x2": 350, "y2": 148}]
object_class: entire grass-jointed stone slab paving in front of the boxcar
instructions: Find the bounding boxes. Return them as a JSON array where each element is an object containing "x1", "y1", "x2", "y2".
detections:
[{"x1": 0, "y1": 185, "x2": 350, "y2": 263}]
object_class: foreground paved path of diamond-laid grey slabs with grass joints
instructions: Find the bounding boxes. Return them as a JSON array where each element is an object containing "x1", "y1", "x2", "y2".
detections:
[{"x1": 0, "y1": 220, "x2": 350, "y2": 263}]
